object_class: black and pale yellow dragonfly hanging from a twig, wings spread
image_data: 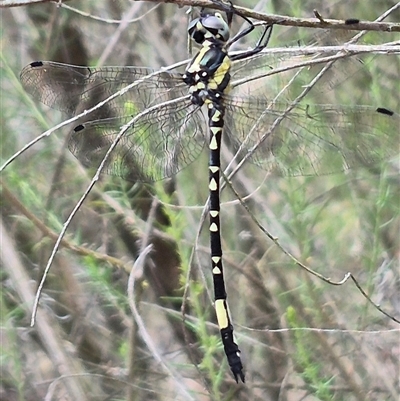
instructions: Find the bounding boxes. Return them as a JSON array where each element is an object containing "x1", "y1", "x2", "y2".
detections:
[{"x1": 20, "y1": 5, "x2": 400, "y2": 382}]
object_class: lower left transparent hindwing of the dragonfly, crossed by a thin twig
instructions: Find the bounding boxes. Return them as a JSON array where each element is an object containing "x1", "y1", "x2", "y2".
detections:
[{"x1": 69, "y1": 96, "x2": 207, "y2": 182}]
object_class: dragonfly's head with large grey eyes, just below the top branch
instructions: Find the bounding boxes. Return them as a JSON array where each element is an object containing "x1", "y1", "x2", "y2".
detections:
[{"x1": 188, "y1": 13, "x2": 229, "y2": 44}]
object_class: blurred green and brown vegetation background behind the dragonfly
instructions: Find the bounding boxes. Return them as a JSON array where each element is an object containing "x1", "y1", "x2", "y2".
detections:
[{"x1": 0, "y1": 0, "x2": 400, "y2": 401}]
